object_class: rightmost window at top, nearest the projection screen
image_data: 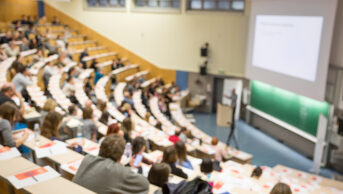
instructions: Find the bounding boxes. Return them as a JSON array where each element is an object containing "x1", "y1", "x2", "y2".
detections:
[{"x1": 187, "y1": 0, "x2": 245, "y2": 11}]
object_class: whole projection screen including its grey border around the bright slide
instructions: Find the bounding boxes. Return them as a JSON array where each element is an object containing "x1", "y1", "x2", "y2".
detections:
[{"x1": 246, "y1": 0, "x2": 337, "y2": 101}]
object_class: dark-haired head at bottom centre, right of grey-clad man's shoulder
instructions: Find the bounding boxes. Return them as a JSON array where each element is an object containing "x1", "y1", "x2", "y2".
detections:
[{"x1": 148, "y1": 163, "x2": 171, "y2": 187}]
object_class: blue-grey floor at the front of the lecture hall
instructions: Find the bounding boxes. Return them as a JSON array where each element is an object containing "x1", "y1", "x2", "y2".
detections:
[{"x1": 194, "y1": 113, "x2": 338, "y2": 178}]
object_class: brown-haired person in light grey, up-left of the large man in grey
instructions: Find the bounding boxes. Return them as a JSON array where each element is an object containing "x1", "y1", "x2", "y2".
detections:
[{"x1": 82, "y1": 107, "x2": 98, "y2": 142}]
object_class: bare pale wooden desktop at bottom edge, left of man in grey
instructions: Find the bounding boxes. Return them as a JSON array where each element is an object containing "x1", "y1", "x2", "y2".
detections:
[{"x1": 24, "y1": 177, "x2": 94, "y2": 194}]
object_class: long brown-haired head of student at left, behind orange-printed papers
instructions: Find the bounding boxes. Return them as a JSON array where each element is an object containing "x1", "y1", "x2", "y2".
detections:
[{"x1": 41, "y1": 111, "x2": 63, "y2": 139}]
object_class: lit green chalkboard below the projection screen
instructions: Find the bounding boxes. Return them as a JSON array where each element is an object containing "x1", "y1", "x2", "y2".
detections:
[{"x1": 250, "y1": 81, "x2": 329, "y2": 136}]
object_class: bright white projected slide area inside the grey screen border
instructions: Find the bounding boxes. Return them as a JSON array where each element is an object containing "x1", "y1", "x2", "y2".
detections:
[{"x1": 252, "y1": 15, "x2": 323, "y2": 82}]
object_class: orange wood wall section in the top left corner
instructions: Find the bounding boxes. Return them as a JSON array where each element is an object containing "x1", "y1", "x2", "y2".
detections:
[{"x1": 0, "y1": 0, "x2": 38, "y2": 22}]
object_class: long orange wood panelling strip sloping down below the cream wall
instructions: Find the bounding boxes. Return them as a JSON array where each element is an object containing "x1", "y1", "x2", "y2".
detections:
[{"x1": 45, "y1": 4, "x2": 176, "y2": 83}]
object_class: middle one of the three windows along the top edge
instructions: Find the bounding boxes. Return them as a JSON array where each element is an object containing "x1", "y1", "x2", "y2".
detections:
[{"x1": 135, "y1": 0, "x2": 180, "y2": 8}]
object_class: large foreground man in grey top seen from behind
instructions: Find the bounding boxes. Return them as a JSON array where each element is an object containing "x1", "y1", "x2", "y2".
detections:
[{"x1": 73, "y1": 134, "x2": 149, "y2": 194}]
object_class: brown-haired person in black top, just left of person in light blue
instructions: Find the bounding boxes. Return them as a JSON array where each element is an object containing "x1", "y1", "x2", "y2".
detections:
[{"x1": 162, "y1": 146, "x2": 188, "y2": 179}]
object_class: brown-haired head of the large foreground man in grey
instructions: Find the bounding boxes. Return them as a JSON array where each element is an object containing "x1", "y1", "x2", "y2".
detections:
[{"x1": 99, "y1": 134, "x2": 125, "y2": 162}]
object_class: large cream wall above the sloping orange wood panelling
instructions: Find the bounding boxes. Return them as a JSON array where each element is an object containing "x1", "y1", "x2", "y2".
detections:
[{"x1": 45, "y1": 0, "x2": 250, "y2": 76}]
